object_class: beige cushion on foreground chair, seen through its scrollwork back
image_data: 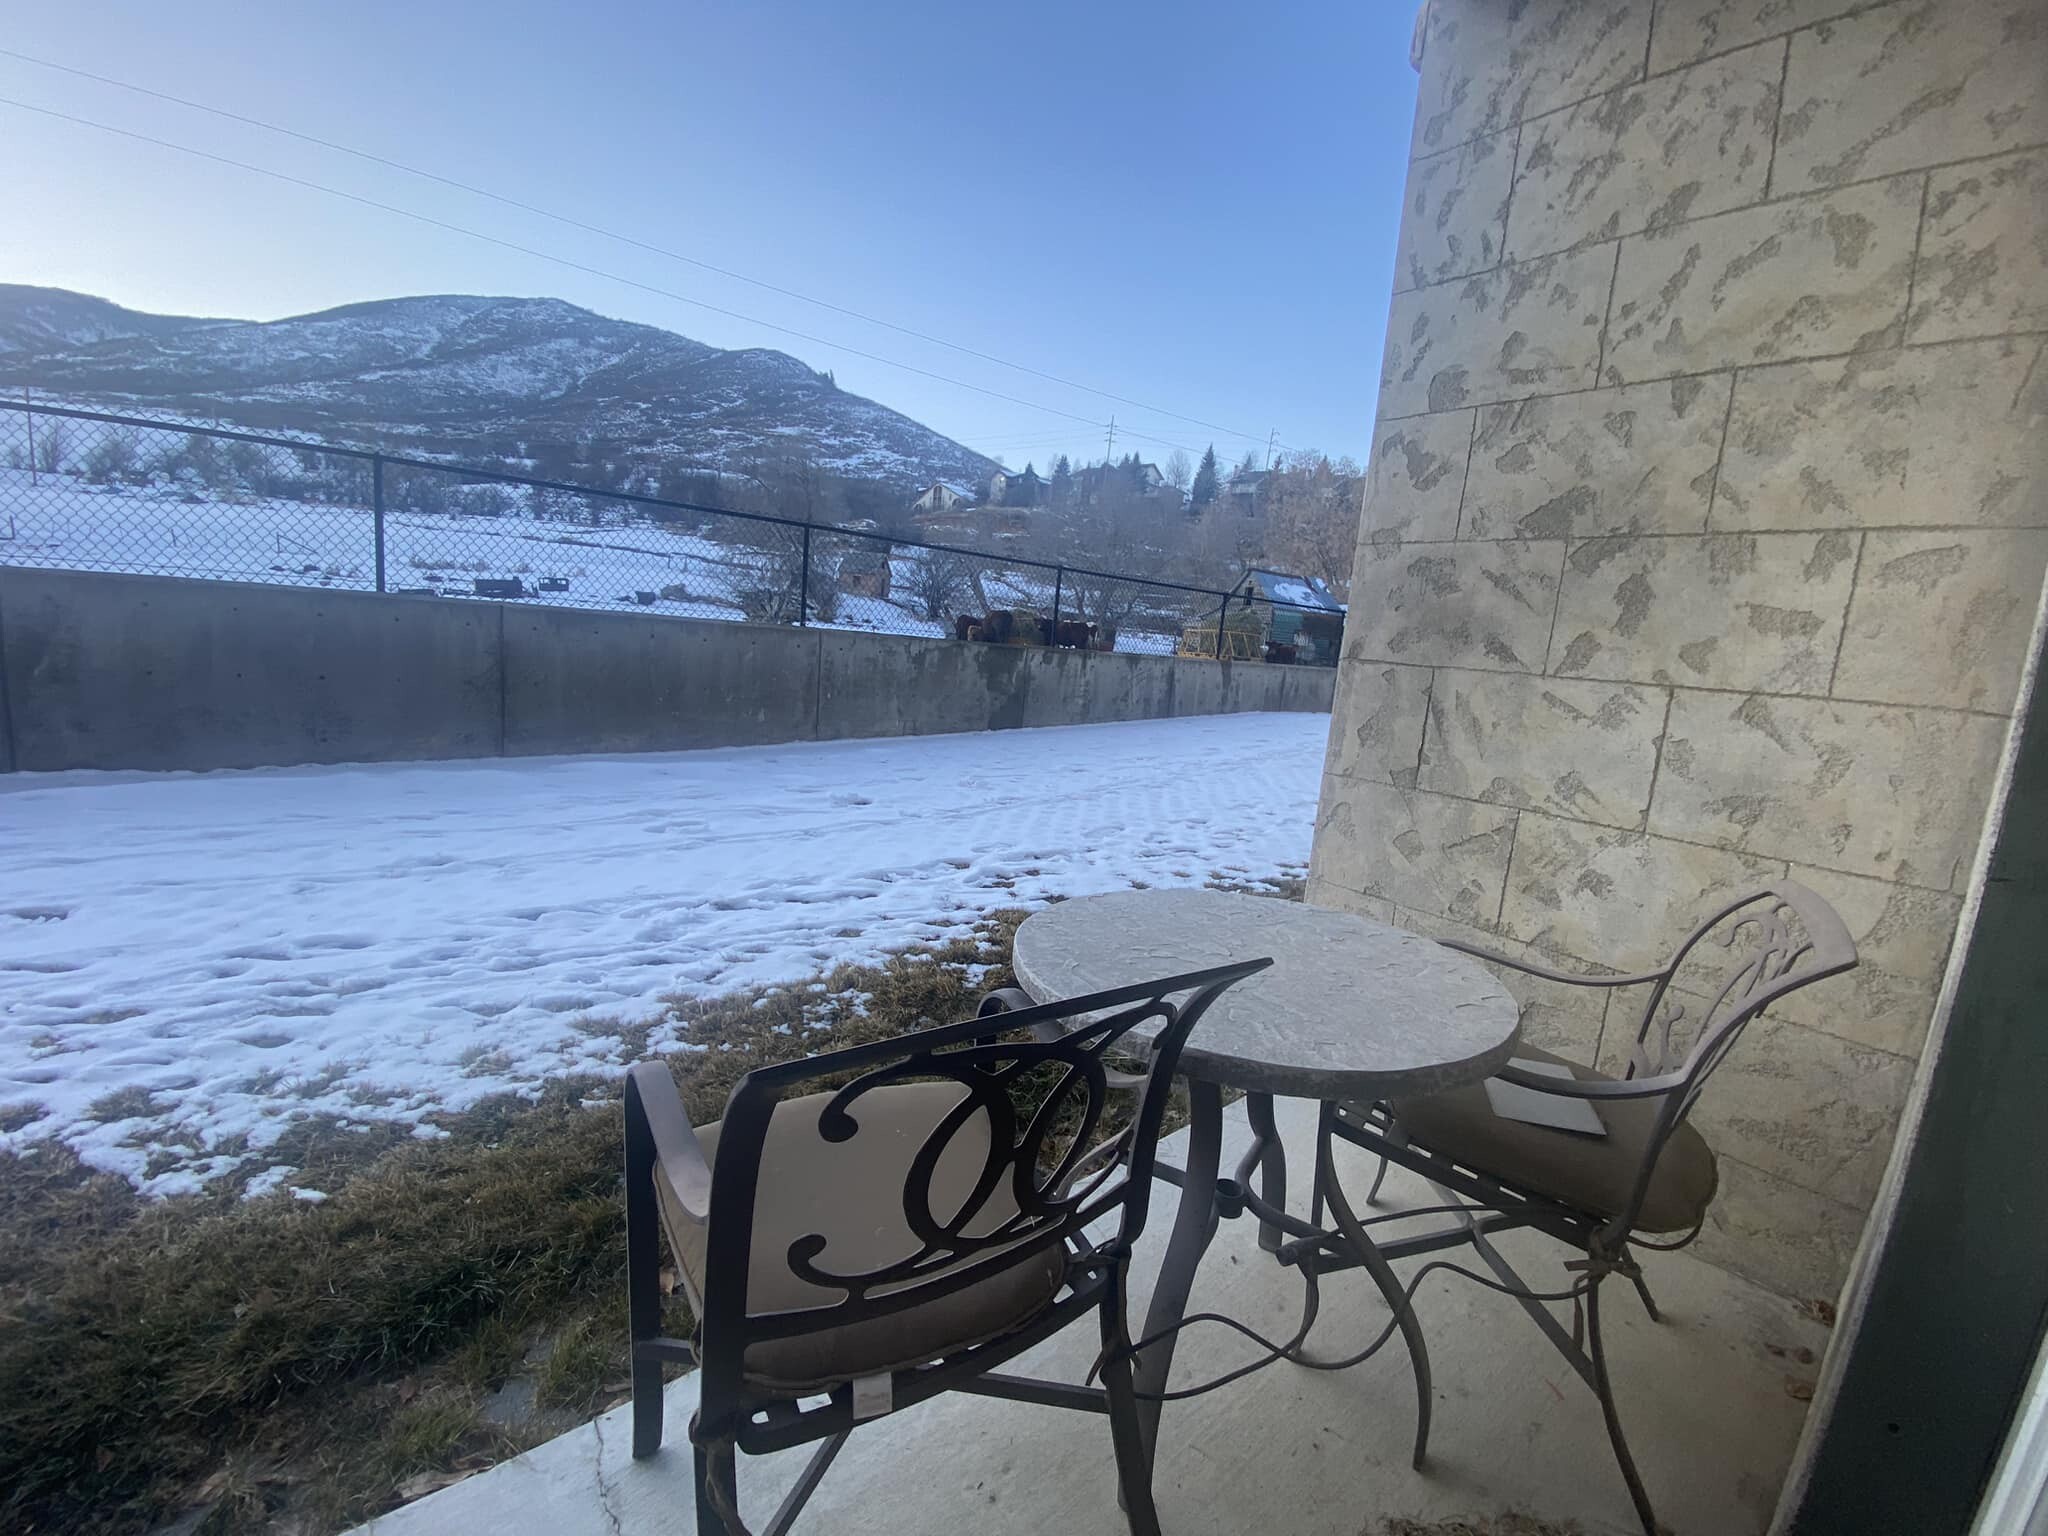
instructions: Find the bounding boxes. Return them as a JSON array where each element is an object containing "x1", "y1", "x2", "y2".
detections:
[{"x1": 655, "y1": 1083, "x2": 1067, "y2": 1393}]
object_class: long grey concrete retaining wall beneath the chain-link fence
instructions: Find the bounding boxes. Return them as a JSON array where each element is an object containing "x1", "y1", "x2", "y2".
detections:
[{"x1": 0, "y1": 567, "x2": 1335, "y2": 772}]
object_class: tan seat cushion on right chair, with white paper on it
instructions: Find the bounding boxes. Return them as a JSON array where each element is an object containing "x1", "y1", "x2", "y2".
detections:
[{"x1": 1393, "y1": 1047, "x2": 1720, "y2": 1233}]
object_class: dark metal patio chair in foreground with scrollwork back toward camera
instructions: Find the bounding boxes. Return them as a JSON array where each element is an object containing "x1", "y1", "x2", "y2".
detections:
[{"x1": 627, "y1": 961, "x2": 1270, "y2": 1536}]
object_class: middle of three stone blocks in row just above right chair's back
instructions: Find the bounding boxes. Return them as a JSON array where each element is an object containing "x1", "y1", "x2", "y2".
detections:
[{"x1": 1417, "y1": 668, "x2": 1665, "y2": 827}]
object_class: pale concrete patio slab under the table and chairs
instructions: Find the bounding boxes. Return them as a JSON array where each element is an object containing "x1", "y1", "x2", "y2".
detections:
[{"x1": 358, "y1": 1102, "x2": 1827, "y2": 1536}]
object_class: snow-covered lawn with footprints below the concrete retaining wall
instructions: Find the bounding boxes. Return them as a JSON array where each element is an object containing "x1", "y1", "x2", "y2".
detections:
[{"x1": 0, "y1": 715, "x2": 1329, "y2": 1192}]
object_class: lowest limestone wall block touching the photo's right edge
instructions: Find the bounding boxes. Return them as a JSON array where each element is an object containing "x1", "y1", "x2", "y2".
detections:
[{"x1": 1833, "y1": 528, "x2": 2048, "y2": 713}]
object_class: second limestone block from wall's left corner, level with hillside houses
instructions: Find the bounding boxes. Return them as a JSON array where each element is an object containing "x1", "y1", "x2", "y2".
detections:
[{"x1": 1462, "y1": 375, "x2": 1733, "y2": 539}]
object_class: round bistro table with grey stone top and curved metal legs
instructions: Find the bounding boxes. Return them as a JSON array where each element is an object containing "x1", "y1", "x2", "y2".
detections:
[{"x1": 1012, "y1": 891, "x2": 1518, "y2": 1464}]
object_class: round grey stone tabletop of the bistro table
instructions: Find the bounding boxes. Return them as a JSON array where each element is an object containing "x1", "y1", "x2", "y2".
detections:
[{"x1": 1014, "y1": 891, "x2": 1520, "y2": 1100}]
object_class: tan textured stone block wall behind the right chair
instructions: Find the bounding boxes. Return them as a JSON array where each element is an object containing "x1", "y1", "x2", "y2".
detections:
[{"x1": 1309, "y1": 0, "x2": 2048, "y2": 1296}]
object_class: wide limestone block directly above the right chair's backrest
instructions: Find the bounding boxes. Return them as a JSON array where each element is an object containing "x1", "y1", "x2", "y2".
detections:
[{"x1": 1651, "y1": 688, "x2": 2005, "y2": 889}]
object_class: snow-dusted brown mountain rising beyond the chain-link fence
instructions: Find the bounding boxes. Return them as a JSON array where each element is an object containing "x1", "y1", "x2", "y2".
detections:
[{"x1": 0, "y1": 285, "x2": 995, "y2": 487}]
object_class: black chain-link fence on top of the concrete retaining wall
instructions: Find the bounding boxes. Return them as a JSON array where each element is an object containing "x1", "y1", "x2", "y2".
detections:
[{"x1": 0, "y1": 401, "x2": 1341, "y2": 666}]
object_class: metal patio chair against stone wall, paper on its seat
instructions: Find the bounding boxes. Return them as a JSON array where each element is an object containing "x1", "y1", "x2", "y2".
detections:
[{"x1": 1305, "y1": 881, "x2": 1855, "y2": 1536}]
